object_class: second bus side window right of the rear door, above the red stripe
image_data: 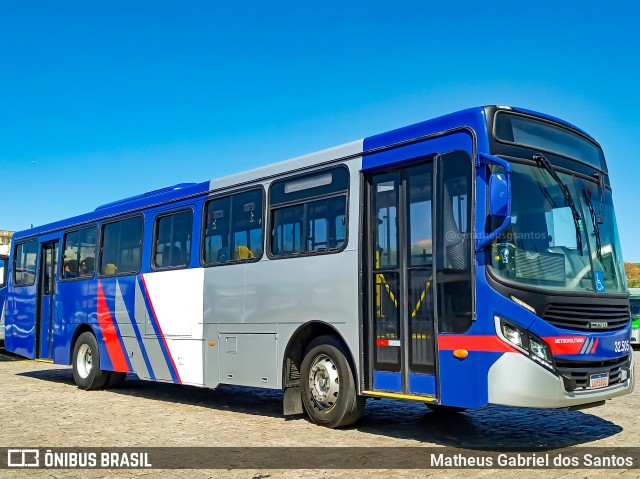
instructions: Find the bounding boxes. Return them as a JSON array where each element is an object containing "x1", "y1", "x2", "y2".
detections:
[{"x1": 100, "y1": 216, "x2": 143, "y2": 276}]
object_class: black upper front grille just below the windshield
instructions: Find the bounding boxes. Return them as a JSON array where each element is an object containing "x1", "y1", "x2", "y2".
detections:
[{"x1": 542, "y1": 303, "x2": 631, "y2": 331}]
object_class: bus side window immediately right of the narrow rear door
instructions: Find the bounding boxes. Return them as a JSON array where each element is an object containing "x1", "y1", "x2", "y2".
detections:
[{"x1": 61, "y1": 227, "x2": 96, "y2": 279}]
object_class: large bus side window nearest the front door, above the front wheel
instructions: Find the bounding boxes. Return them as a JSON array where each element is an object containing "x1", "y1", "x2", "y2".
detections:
[{"x1": 271, "y1": 168, "x2": 349, "y2": 256}]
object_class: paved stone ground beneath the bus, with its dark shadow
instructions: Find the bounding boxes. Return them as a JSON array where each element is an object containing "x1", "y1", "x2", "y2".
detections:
[{"x1": 0, "y1": 351, "x2": 640, "y2": 479}]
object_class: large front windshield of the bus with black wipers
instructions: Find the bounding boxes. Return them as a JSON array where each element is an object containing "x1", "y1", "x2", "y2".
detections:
[{"x1": 491, "y1": 163, "x2": 626, "y2": 293}]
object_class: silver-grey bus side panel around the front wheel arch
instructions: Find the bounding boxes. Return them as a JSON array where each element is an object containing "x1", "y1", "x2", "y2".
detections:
[{"x1": 204, "y1": 159, "x2": 361, "y2": 387}]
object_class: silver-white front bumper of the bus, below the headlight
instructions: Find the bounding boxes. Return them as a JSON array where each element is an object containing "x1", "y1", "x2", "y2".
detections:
[{"x1": 488, "y1": 352, "x2": 635, "y2": 408}]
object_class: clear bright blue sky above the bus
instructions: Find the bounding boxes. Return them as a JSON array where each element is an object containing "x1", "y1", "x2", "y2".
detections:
[{"x1": 0, "y1": 0, "x2": 640, "y2": 262}]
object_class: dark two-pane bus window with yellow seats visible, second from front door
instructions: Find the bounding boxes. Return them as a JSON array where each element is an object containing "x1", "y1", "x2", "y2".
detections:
[{"x1": 202, "y1": 189, "x2": 263, "y2": 265}]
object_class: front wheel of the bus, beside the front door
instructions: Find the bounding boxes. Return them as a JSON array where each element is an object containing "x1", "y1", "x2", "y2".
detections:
[{"x1": 301, "y1": 336, "x2": 365, "y2": 428}]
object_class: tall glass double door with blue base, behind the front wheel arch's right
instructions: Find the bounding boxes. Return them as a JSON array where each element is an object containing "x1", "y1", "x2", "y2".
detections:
[{"x1": 367, "y1": 162, "x2": 437, "y2": 400}]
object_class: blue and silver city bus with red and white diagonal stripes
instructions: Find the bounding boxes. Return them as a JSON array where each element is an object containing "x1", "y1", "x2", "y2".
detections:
[{"x1": 6, "y1": 106, "x2": 634, "y2": 427}]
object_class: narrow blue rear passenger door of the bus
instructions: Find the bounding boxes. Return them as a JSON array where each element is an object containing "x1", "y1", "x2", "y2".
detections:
[{"x1": 35, "y1": 241, "x2": 58, "y2": 359}]
